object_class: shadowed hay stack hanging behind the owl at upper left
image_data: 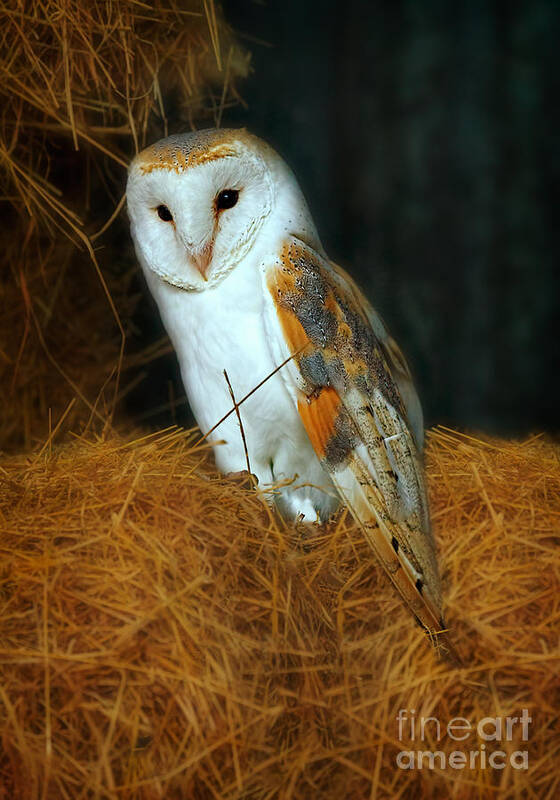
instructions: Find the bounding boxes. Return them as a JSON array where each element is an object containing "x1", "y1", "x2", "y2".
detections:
[{"x1": 0, "y1": 0, "x2": 248, "y2": 450}]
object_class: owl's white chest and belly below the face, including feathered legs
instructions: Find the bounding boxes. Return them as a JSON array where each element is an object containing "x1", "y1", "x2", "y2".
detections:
[{"x1": 145, "y1": 253, "x2": 337, "y2": 520}]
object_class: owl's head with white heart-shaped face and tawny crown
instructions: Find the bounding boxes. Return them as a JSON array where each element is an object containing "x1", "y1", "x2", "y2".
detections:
[{"x1": 127, "y1": 129, "x2": 321, "y2": 291}]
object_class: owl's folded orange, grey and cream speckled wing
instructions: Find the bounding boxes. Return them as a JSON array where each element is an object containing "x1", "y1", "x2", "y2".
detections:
[{"x1": 265, "y1": 238, "x2": 456, "y2": 653}]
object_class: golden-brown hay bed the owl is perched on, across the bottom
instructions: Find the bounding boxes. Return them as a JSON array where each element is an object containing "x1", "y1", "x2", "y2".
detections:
[{"x1": 0, "y1": 429, "x2": 560, "y2": 800}]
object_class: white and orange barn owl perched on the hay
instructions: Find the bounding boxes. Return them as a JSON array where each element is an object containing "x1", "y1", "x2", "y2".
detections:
[{"x1": 127, "y1": 129, "x2": 456, "y2": 651}]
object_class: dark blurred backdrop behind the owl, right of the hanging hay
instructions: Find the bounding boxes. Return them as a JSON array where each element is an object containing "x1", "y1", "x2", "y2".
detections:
[{"x1": 128, "y1": 0, "x2": 560, "y2": 434}]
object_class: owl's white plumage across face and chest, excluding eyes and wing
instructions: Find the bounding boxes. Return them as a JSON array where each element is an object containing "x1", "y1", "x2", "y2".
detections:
[{"x1": 128, "y1": 130, "x2": 338, "y2": 521}]
